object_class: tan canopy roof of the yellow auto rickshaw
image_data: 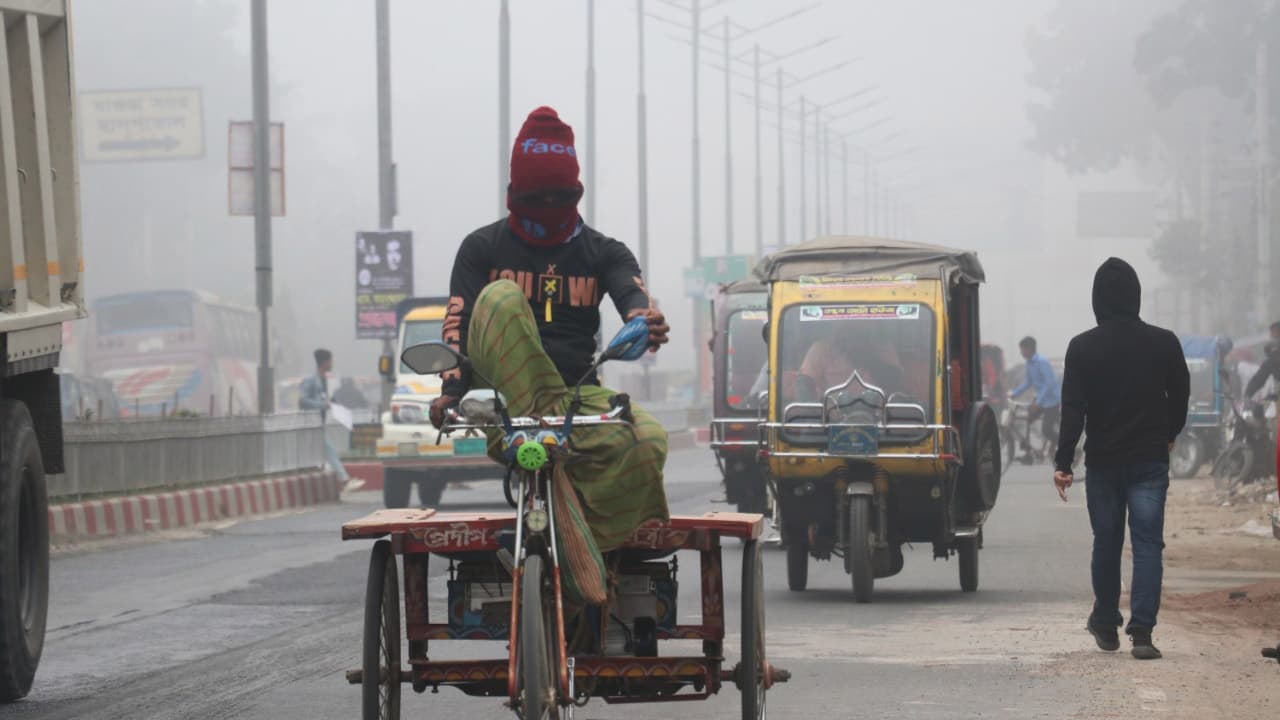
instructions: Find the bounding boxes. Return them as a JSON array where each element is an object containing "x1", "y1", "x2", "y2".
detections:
[{"x1": 755, "y1": 236, "x2": 986, "y2": 283}]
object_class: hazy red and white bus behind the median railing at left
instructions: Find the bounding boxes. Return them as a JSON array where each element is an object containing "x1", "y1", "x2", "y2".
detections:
[{"x1": 84, "y1": 290, "x2": 259, "y2": 416}]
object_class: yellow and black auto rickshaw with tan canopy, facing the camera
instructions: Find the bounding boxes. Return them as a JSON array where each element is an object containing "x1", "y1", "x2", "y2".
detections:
[{"x1": 756, "y1": 237, "x2": 1001, "y2": 602}]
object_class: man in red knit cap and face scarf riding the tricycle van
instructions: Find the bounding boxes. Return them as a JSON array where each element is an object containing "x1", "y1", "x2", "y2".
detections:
[{"x1": 430, "y1": 108, "x2": 669, "y2": 551}]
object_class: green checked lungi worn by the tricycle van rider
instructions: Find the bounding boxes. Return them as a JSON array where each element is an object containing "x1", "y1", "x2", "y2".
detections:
[{"x1": 467, "y1": 281, "x2": 669, "y2": 551}]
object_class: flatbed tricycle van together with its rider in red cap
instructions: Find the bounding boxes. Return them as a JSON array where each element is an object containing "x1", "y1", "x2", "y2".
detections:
[{"x1": 342, "y1": 108, "x2": 787, "y2": 720}]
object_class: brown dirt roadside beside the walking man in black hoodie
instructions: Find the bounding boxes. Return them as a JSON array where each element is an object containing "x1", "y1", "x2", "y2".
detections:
[{"x1": 1053, "y1": 478, "x2": 1280, "y2": 720}]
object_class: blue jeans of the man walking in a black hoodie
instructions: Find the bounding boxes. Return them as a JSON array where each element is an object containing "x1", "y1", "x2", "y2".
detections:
[{"x1": 1084, "y1": 462, "x2": 1169, "y2": 633}]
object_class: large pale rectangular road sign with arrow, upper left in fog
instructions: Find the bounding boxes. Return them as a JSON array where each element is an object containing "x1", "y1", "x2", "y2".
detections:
[{"x1": 79, "y1": 87, "x2": 205, "y2": 163}]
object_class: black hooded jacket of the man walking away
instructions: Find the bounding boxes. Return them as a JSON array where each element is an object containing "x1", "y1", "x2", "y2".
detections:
[{"x1": 1055, "y1": 258, "x2": 1190, "y2": 473}]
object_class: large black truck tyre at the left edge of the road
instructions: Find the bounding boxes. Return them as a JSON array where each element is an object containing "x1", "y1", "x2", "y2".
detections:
[{"x1": 0, "y1": 400, "x2": 49, "y2": 702}]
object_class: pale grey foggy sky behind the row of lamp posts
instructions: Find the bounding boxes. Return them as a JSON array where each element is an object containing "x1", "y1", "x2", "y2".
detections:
[{"x1": 73, "y1": 0, "x2": 1144, "y2": 374}]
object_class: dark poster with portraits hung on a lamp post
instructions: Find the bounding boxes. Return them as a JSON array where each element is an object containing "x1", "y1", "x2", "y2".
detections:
[{"x1": 356, "y1": 231, "x2": 413, "y2": 340}]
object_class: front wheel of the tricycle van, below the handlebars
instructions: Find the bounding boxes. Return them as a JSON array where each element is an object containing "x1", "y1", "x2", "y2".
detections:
[{"x1": 518, "y1": 555, "x2": 556, "y2": 720}]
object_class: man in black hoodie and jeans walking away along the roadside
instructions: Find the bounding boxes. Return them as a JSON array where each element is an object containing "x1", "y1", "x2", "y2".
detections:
[{"x1": 1053, "y1": 258, "x2": 1190, "y2": 660}]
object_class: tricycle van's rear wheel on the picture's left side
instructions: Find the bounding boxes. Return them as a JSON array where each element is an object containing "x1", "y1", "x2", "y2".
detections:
[{"x1": 361, "y1": 541, "x2": 401, "y2": 720}]
